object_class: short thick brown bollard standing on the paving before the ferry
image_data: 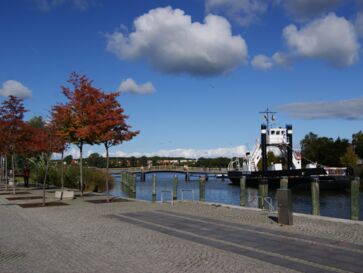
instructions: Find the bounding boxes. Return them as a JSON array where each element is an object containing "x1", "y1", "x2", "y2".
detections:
[{"x1": 276, "y1": 189, "x2": 293, "y2": 225}]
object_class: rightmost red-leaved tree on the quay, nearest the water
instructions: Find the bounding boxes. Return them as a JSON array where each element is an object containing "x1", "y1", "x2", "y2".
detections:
[{"x1": 96, "y1": 92, "x2": 140, "y2": 201}]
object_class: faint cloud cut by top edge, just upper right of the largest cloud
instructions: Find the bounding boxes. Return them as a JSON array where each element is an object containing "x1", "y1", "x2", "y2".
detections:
[{"x1": 205, "y1": 0, "x2": 267, "y2": 26}]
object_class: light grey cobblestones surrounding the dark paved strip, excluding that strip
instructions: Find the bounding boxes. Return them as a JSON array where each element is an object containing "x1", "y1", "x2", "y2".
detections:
[{"x1": 0, "y1": 189, "x2": 363, "y2": 273}]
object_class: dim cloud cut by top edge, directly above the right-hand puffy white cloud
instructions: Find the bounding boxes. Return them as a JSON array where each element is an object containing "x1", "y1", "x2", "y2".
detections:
[{"x1": 282, "y1": 0, "x2": 343, "y2": 21}]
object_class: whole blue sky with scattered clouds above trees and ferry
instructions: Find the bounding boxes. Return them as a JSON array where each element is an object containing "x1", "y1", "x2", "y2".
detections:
[{"x1": 0, "y1": 0, "x2": 363, "y2": 156}]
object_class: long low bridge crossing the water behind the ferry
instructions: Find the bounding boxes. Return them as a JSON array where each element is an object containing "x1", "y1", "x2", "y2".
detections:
[{"x1": 109, "y1": 166, "x2": 227, "y2": 181}]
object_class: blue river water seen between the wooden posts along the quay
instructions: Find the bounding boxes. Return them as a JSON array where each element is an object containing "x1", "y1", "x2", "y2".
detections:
[{"x1": 111, "y1": 173, "x2": 363, "y2": 220}]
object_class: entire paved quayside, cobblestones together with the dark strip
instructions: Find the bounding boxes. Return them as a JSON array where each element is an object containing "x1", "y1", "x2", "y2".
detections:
[{"x1": 0, "y1": 189, "x2": 363, "y2": 273}]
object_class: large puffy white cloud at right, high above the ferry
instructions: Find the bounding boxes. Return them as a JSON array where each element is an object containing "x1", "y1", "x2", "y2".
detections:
[{"x1": 283, "y1": 13, "x2": 360, "y2": 67}]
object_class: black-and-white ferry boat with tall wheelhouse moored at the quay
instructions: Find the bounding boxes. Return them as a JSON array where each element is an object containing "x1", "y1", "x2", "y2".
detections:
[{"x1": 228, "y1": 108, "x2": 351, "y2": 189}]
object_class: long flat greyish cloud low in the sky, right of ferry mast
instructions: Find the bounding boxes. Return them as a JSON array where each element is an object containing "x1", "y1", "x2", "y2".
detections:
[{"x1": 279, "y1": 97, "x2": 363, "y2": 120}]
